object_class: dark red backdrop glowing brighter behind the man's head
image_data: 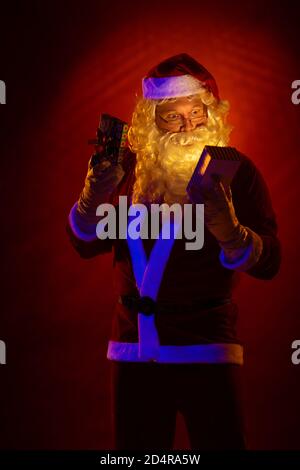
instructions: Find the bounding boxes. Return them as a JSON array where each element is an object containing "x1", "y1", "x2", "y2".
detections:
[{"x1": 0, "y1": 1, "x2": 300, "y2": 449}]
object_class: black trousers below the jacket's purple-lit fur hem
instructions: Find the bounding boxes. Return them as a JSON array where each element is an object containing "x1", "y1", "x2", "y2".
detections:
[{"x1": 111, "y1": 361, "x2": 246, "y2": 451}]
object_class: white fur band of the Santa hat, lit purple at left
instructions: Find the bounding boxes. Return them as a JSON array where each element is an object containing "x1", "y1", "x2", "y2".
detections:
[{"x1": 142, "y1": 75, "x2": 203, "y2": 100}]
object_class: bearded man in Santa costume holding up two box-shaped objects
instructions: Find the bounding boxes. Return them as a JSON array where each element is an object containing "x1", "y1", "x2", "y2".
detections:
[{"x1": 67, "y1": 54, "x2": 280, "y2": 450}]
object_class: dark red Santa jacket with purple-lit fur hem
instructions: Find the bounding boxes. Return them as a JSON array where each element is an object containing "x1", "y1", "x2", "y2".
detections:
[{"x1": 67, "y1": 150, "x2": 281, "y2": 364}]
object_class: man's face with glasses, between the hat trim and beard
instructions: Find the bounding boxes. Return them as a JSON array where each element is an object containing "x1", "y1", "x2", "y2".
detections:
[{"x1": 155, "y1": 97, "x2": 207, "y2": 132}]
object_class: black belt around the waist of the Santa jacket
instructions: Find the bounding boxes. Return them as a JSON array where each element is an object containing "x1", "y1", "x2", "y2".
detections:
[{"x1": 119, "y1": 295, "x2": 231, "y2": 315}]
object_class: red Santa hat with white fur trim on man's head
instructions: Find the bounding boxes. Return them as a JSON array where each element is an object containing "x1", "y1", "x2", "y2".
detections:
[{"x1": 142, "y1": 53, "x2": 220, "y2": 100}]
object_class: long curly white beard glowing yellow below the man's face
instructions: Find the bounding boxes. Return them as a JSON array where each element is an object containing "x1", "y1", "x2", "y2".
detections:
[{"x1": 133, "y1": 123, "x2": 226, "y2": 204}]
